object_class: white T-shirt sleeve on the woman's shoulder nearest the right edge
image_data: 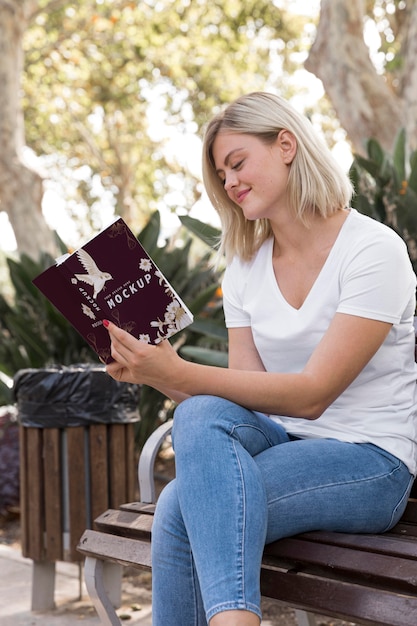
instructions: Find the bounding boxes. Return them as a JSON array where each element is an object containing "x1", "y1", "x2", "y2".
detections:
[{"x1": 337, "y1": 229, "x2": 416, "y2": 324}]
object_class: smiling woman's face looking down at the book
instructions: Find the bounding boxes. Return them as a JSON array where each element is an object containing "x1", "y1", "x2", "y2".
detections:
[{"x1": 213, "y1": 130, "x2": 296, "y2": 220}]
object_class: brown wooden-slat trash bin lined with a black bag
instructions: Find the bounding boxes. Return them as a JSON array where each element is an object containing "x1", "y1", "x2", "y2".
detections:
[{"x1": 13, "y1": 364, "x2": 140, "y2": 610}]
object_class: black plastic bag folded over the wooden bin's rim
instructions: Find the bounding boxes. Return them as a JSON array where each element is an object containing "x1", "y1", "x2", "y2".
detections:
[{"x1": 13, "y1": 364, "x2": 140, "y2": 428}]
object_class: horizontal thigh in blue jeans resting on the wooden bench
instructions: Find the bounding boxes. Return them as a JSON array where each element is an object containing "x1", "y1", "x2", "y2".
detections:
[{"x1": 255, "y1": 439, "x2": 413, "y2": 543}]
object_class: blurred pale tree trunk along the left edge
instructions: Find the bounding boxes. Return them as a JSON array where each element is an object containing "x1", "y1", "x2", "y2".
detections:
[{"x1": 0, "y1": 0, "x2": 56, "y2": 260}]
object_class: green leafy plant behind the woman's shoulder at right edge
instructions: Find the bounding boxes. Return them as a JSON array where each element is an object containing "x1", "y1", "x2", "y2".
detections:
[{"x1": 350, "y1": 130, "x2": 417, "y2": 271}]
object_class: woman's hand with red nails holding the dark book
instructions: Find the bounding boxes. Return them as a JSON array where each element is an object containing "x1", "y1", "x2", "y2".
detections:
[{"x1": 102, "y1": 322, "x2": 182, "y2": 388}]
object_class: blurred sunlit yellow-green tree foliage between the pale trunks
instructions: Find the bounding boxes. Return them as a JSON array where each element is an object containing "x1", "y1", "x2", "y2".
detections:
[{"x1": 22, "y1": 0, "x2": 307, "y2": 239}]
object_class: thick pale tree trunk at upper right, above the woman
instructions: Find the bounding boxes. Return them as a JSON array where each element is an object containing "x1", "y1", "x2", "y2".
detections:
[{"x1": 305, "y1": 0, "x2": 404, "y2": 154}]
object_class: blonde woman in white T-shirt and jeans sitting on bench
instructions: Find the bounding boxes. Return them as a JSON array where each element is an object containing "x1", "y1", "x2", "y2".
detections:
[{"x1": 106, "y1": 93, "x2": 417, "y2": 626}]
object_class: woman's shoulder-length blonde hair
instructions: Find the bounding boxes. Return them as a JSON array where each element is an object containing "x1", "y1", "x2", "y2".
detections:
[{"x1": 203, "y1": 92, "x2": 352, "y2": 261}]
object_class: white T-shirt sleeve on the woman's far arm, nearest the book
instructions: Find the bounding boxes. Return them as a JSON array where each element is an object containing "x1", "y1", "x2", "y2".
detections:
[{"x1": 222, "y1": 257, "x2": 251, "y2": 328}]
